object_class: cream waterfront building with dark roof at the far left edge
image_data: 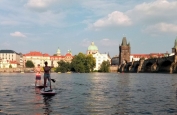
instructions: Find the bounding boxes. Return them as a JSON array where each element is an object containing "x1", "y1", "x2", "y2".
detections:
[{"x1": 0, "y1": 50, "x2": 23, "y2": 68}]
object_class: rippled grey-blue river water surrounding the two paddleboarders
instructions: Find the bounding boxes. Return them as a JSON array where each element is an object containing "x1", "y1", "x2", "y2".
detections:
[{"x1": 0, "y1": 73, "x2": 177, "y2": 115}]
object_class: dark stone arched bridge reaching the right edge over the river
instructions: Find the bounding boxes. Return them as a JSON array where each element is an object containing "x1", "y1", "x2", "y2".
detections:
[{"x1": 118, "y1": 54, "x2": 177, "y2": 73}]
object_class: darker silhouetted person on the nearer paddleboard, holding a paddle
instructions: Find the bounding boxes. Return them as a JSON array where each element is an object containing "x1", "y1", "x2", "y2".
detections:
[{"x1": 43, "y1": 61, "x2": 53, "y2": 91}]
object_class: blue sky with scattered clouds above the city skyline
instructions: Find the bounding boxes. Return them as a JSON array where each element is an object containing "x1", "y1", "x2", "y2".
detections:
[{"x1": 0, "y1": 0, "x2": 177, "y2": 57}]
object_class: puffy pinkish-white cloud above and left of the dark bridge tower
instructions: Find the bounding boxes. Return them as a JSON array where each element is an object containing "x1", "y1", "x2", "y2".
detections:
[{"x1": 93, "y1": 11, "x2": 132, "y2": 28}]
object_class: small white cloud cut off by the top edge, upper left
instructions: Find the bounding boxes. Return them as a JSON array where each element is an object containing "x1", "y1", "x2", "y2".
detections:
[{"x1": 25, "y1": 0, "x2": 57, "y2": 12}]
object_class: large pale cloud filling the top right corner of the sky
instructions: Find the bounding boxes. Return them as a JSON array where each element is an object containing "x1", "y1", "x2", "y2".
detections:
[{"x1": 125, "y1": 0, "x2": 177, "y2": 23}]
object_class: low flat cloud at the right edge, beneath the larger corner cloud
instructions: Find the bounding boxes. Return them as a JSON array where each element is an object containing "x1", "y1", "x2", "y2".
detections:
[{"x1": 143, "y1": 23, "x2": 177, "y2": 34}]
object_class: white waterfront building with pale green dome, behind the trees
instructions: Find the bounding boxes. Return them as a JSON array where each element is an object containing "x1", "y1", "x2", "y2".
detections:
[{"x1": 87, "y1": 42, "x2": 111, "y2": 70}]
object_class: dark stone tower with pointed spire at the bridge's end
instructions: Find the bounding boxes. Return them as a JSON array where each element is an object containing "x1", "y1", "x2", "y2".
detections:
[{"x1": 119, "y1": 37, "x2": 131, "y2": 64}]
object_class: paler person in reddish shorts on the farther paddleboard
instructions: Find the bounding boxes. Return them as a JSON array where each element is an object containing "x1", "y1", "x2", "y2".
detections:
[{"x1": 34, "y1": 64, "x2": 41, "y2": 86}]
